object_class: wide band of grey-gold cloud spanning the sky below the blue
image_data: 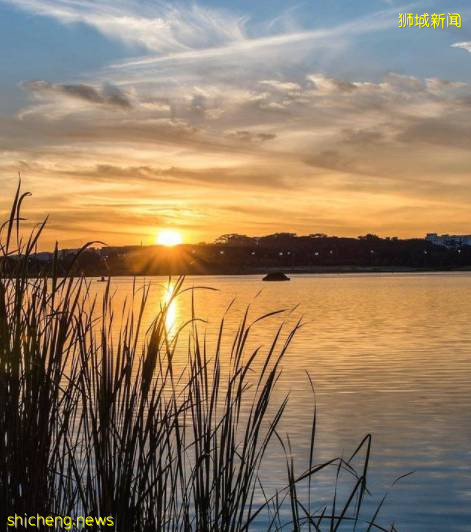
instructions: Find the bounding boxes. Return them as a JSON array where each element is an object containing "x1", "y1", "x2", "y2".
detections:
[{"x1": 8, "y1": 68, "x2": 471, "y2": 173}]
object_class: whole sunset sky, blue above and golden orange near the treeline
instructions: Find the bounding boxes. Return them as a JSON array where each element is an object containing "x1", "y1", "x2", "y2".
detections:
[{"x1": 0, "y1": 0, "x2": 471, "y2": 249}]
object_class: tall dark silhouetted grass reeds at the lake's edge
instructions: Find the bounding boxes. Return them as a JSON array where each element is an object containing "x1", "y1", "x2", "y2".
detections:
[{"x1": 0, "y1": 185, "x2": 394, "y2": 532}]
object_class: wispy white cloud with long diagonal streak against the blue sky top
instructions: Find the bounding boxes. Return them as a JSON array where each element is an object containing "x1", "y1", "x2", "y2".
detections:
[{"x1": 3, "y1": 0, "x2": 397, "y2": 69}]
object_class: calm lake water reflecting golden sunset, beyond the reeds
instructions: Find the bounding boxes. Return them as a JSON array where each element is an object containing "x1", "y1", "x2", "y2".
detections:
[{"x1": 96, "y1": 274, "x2": 471, "y2": 532}]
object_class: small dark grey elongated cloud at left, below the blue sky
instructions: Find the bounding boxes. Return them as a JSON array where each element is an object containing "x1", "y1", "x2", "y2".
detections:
[{"x1": 22, "y1": 80, "x2": 132, "y2": 109}]
